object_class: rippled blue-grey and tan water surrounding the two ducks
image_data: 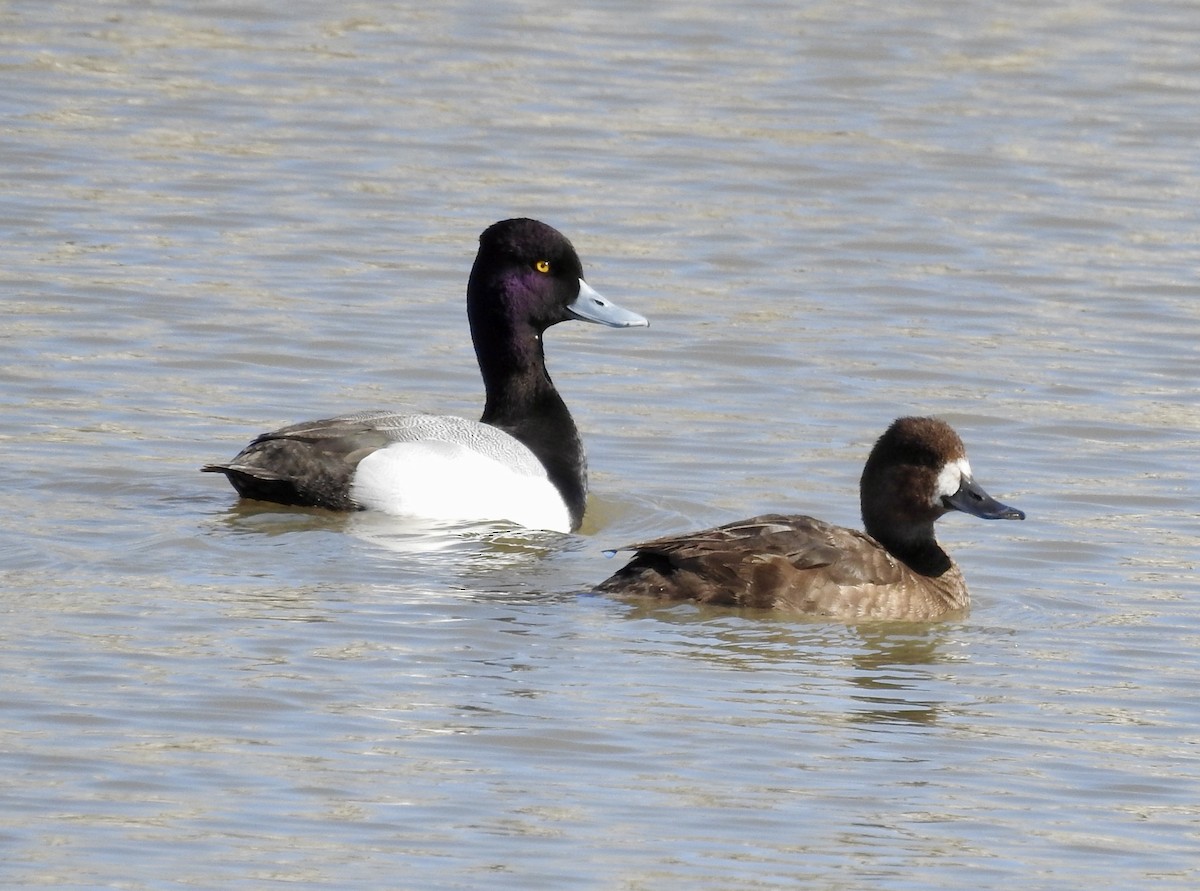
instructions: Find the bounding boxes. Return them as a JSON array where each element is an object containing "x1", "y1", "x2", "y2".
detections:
[{"x1": 0, "y1": 0, "x2": 1200, "y2": 889}]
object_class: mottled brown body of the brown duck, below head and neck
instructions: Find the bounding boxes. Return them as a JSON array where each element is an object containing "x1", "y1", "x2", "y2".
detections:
[{"x1": 598, "y1": 514, "x2": 965, "y2": 621}]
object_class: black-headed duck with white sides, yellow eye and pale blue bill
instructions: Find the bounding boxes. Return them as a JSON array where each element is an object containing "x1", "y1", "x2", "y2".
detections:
[{"x1": 208, "y1": 219, "x2": 649, "y2": 532}]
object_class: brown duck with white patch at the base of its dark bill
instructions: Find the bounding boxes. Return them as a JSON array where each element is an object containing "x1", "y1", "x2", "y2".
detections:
[{"x1": 595, "y1": 417, "x2": 1025, "y2": 622}]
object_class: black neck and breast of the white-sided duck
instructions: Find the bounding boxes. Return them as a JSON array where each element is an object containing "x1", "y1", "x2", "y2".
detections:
[{"x1": 475, "y1": 328, "x2": 588, "y2": 528}]
